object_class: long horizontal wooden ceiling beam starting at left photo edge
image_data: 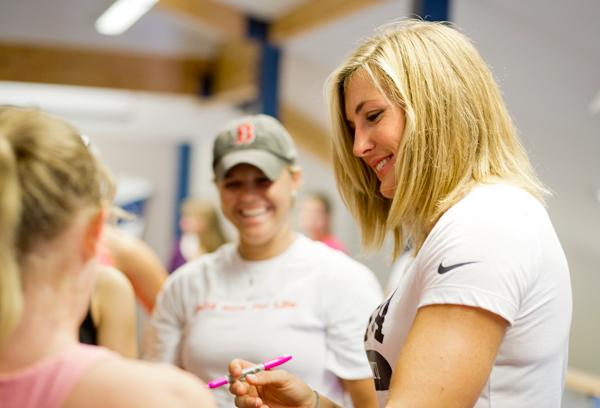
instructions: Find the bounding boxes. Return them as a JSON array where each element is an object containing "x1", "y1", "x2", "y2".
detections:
[{"x1": 0, "y1": 43, "x2": 210, "y2": 95}]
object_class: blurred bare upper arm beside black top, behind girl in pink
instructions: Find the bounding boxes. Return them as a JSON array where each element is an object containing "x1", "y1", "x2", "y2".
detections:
[{"x1": 92, "y1": 266, "x2": 138, "y2": 358}]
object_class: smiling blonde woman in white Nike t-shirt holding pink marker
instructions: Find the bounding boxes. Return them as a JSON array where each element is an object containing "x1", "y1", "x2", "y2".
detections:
[{"x1": 230, "y1": 21, "x2": 571, "y2": 408}]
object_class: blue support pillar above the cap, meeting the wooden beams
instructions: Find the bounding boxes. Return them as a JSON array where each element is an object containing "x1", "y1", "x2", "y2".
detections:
[{"x1": 248, "y1": 18, "x2": 281, "y2": 117}]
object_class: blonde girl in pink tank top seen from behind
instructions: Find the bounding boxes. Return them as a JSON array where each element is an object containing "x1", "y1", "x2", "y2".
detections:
[{"x1": 0, "y1": 108, "x2": 214, "y2": 408}]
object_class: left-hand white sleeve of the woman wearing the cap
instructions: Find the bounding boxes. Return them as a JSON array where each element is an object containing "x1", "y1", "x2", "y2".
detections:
[{"x1": 142, "y1": 271, "x2": 185, "y2": 367}]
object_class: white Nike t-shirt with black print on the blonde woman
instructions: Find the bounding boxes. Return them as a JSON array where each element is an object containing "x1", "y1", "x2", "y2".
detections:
[{"x1": 365, "y1": 184, "x2": 572, "y2": 408}]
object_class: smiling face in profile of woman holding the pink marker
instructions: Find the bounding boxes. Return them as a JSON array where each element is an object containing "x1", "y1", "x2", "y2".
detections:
[{"x1": 344, "y1": 71, "x2": 405, "y2": 198}]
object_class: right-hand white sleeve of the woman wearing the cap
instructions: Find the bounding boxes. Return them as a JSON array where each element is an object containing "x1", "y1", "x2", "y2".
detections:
[{"x1": 322, "y1": 261, "x2": 383, "y2": 380}]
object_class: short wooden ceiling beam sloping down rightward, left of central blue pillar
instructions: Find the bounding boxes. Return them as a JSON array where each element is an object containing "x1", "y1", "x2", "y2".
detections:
[{"x1": 155, "y1": 0, "x2": 247, "y2": 38}]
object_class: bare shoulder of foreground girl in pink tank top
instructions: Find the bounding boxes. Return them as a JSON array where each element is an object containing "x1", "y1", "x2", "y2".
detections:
[{"x1": 64, "y1": 358, "x2": 216, "y2": 408}]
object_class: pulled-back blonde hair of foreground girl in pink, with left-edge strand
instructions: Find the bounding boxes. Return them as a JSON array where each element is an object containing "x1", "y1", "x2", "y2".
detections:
[{"x1": 0, "y1": 107, "x2": 112, "y2": 343}]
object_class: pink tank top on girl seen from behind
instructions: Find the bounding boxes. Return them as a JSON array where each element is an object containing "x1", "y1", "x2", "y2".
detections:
[{"x1": 0, "y1": 344, "x2": 113, "y2": 408}]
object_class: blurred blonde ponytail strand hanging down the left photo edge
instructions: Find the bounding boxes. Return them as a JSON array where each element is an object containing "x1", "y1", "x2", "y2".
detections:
[{"x1": 0, "y1": 134, "x2": 23, "y2": 345}]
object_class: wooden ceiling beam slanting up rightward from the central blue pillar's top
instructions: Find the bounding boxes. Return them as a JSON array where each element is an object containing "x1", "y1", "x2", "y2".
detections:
[{"x1": 269, "y1": 0, "x2": 384, "y2": 44}]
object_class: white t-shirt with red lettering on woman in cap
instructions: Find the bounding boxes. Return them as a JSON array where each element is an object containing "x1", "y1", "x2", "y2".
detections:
[{"x1": 144, "y1": 235, "x2": 382, "y2": 407}]
